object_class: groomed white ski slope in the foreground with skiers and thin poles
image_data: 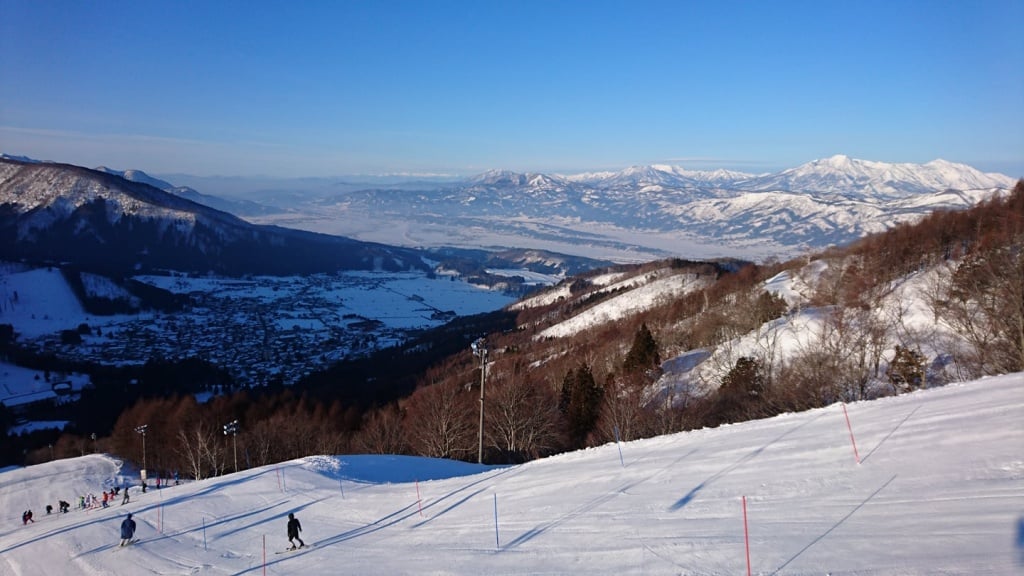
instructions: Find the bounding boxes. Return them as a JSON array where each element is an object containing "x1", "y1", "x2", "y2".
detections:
[{"x1": 0, "y1": 374, "x2": 1024, "y2": 576}]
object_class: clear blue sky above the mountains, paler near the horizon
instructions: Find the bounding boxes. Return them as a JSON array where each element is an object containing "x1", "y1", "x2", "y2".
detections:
[{"x1": 0, "y1": 0, "x2": 1024, "y2": 176}]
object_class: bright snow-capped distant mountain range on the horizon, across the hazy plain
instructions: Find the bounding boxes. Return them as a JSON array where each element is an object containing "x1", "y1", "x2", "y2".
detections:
[{"x1": 356, "y1": 156, "x2": 1014, "y2": 259}]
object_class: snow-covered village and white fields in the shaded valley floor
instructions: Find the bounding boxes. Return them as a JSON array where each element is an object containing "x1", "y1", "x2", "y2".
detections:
[{"x1": 0, "y1": 264, "x2": 520, "y2": 389}]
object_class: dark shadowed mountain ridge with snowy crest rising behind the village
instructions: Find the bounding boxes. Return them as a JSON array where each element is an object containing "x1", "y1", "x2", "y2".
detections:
[{"x1": 0, "y1": 155, "x2": 426, "y2": 274}]
